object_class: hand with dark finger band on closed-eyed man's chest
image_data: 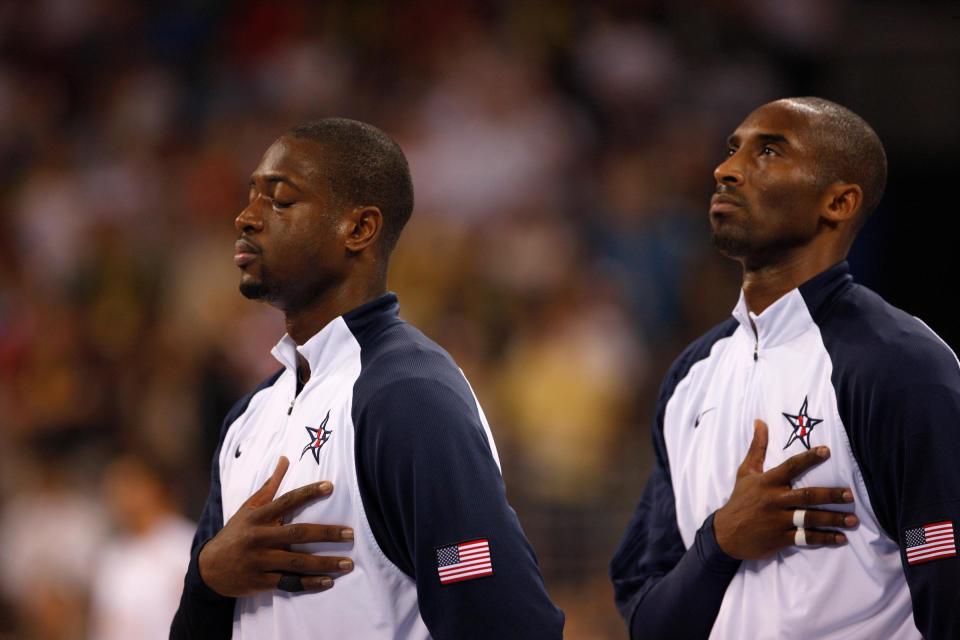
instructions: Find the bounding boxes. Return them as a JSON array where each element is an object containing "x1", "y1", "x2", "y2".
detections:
[{"x1": 199, "y1": 457, "x2": 353, "y2": 597}]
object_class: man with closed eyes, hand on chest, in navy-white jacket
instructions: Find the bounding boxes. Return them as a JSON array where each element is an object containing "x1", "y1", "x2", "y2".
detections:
[{"x1": 171, "y1": 119, "x2": 563, "y2": 640}]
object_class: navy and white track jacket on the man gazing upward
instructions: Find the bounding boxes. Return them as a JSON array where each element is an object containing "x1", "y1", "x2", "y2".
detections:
[{"x1": 610, "y1": 263, "x2": 960, "y2": 640}]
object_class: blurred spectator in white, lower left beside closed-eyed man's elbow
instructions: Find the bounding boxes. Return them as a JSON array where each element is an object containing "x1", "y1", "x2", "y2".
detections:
[{"x1": 88, "y1": 453, "x2": 196, "y2": 640}]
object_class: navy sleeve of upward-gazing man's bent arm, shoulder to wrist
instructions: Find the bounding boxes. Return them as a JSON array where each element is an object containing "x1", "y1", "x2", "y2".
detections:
[{"x1": 610, "y1": 323, "x2": 740, "y2": 639}]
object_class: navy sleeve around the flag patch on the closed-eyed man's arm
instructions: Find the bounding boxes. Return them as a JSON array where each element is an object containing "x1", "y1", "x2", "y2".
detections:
[{"x1": 354, "y1": 378, "x2": 564, "y2": 640}]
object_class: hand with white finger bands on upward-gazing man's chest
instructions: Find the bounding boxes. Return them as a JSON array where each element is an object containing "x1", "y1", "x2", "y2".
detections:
[{"x1": 713, "y1": 420, "x2": 859, "y2": 560}]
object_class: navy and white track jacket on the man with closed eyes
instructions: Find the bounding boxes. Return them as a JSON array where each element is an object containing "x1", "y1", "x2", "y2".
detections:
[{"x1": 171, "y1": 294, "x2": 563, "y2": 640}]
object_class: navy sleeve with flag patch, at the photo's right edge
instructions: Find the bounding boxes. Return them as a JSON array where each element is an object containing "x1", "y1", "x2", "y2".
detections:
[{"x1": 824, "y1": 316, "x2": 960, "y2": 638}]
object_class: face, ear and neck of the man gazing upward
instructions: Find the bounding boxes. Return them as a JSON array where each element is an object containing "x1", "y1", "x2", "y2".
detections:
[{"x1": 710, "y1": 100, "x2": 863, "y2": 314}]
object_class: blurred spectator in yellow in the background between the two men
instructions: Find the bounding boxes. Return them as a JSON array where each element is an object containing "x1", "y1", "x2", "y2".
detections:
[{"x1": 499, "y1": 274, "x2": 646, "y2": 505}]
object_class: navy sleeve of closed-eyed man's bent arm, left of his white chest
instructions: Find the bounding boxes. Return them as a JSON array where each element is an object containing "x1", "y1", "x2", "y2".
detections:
[{"x1": 170, "y1": 370, "x2": 282, "y2": 640}]
